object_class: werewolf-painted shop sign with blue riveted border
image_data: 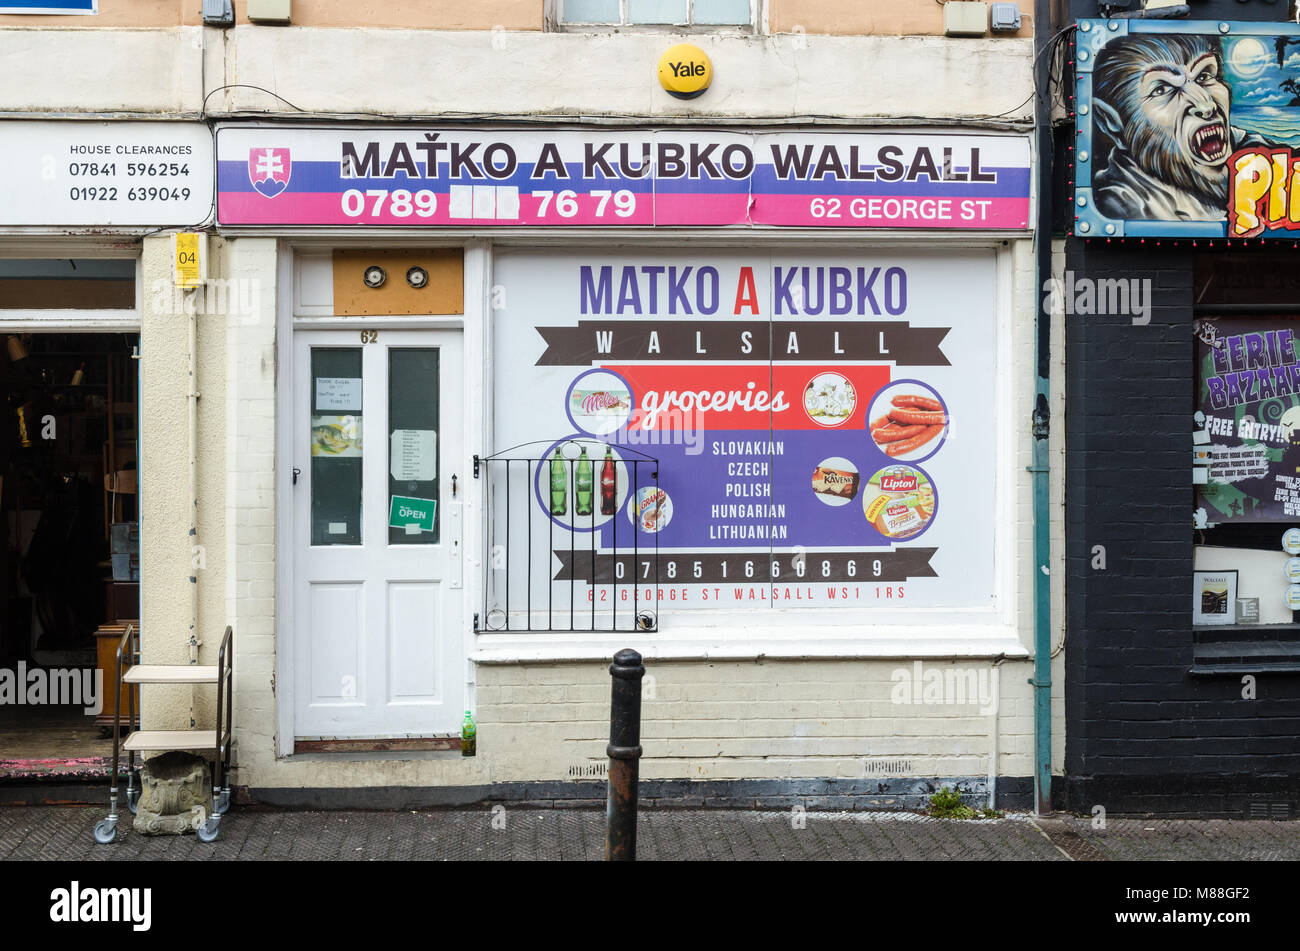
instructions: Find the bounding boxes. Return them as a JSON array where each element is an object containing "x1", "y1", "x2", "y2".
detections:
[{"x1": 1074, "y1": 19, "x2": 1300, "y2": 239}]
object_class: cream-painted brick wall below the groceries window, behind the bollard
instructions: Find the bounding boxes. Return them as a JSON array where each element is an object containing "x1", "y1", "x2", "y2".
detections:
[{"x1": 478, "y1": 660, "x2": 1032, "y2": 781}]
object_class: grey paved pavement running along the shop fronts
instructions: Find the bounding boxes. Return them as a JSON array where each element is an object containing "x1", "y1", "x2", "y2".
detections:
[{"x1": 0, "y1": 804, "x2": 1300, "y2": 861}]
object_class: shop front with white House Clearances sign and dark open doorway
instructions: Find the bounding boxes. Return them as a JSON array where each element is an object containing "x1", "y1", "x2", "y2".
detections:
[{"x1": 0, "y1": 121, "x2": 212, "y2": 799}]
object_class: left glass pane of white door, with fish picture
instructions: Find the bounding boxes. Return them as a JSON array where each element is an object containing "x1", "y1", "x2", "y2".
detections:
[{"x1": 309, "y1": 347, "x2": 363, "y2": 544}]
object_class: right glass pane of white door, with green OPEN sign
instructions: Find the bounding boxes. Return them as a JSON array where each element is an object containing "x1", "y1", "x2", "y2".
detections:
[{"x1": 389, "y1": 347, "x2": 442, "y2": 544}]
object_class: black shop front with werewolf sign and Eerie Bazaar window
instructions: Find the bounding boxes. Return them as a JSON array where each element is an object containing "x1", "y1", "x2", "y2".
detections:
[{"x1": 1062, "y1": 14, "x2": 1300, "y2": 818}]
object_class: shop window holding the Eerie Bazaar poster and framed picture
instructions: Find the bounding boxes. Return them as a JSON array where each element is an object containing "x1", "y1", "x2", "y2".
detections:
[{"x1": 1192, "y1": 316, "x2": 1300, "y2": 660}]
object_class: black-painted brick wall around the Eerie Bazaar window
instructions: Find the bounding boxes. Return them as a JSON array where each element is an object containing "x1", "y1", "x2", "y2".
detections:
[{"x1": 1056, "y1": 239, "x2": 1300, "y2": 816}]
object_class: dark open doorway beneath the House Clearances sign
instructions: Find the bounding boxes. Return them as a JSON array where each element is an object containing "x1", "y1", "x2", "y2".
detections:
[{"x1": 0, "y1": 260, "x2": 139, "y2": 783}]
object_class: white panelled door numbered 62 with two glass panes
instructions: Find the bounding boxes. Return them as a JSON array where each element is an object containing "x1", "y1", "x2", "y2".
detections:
[{"x1": 291, "y1": 330, "x2": 468, "y2": 738}]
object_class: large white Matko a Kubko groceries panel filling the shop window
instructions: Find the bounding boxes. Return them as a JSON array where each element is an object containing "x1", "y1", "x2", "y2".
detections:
[{"x1": 486, "y1": 251, "x2": 998, "y2": 630}]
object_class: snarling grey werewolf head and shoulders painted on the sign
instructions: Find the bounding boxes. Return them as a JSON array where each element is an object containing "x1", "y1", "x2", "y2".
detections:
[{"x1": 1092, "y1": 34, "x2": 1269, "y2": 221}]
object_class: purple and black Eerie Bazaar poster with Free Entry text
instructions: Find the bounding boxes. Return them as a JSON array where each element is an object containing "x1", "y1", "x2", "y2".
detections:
[{"x1": 1195, "y1": 318, "x2": 1300, "y2": 524}]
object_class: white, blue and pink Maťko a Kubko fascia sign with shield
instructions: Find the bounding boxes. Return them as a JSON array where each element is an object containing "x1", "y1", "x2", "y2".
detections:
[{"x1": 217, "y1": 126, "x2": 1030, "y2": 231}]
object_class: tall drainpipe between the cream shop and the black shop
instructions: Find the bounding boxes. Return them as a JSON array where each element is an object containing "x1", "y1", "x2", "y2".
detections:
[{"x1": 1030, "y1": 0, "x2": 1053, "y2": 816}]
